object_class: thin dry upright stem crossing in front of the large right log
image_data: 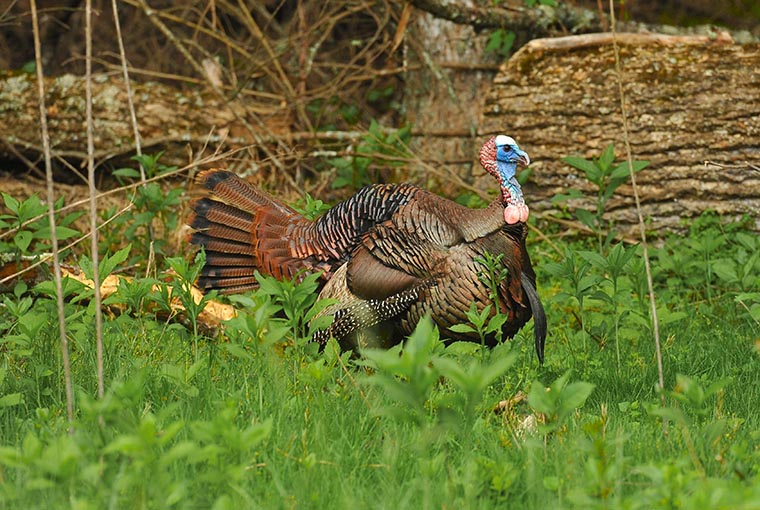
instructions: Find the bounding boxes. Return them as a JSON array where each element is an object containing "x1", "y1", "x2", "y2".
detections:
[{"x1": 610, "y1": 0, "x2": 668, "y2": 426}]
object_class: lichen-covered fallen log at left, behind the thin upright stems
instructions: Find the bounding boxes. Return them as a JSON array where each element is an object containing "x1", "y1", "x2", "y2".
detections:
[{"x1": 0, "y1": 74, "x2": 289, "y2": 182}]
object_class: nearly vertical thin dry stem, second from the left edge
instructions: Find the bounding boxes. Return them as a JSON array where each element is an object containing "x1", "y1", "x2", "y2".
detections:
[{"x1": 84, "y1": 0, "x2": 105, "y2": 402}]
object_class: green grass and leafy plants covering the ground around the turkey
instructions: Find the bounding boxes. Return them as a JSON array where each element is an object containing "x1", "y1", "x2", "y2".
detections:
[{"x1": 0, "y1": 208, "x2": 760, "y2": 509}]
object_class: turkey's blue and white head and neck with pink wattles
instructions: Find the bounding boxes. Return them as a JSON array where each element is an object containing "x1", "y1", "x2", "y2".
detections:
[{"x1": 480, "y1": 135, "x2": 530, "y2": 225}]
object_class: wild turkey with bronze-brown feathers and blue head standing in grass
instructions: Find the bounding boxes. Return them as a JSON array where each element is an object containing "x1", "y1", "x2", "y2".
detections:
[{"x1": 188, "y1": 135, "x2": 546, "y2": 363}]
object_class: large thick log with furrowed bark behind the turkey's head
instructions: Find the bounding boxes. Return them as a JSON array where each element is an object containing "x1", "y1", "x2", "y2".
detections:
[{"x1": 479, "y1": 34, "x2": 760, "y2": 233}]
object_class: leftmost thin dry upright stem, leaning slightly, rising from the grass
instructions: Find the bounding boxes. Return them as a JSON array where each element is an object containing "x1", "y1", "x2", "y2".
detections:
[{"x1": 30, "y1": 0, "x2": 74, "y2": 434}]
